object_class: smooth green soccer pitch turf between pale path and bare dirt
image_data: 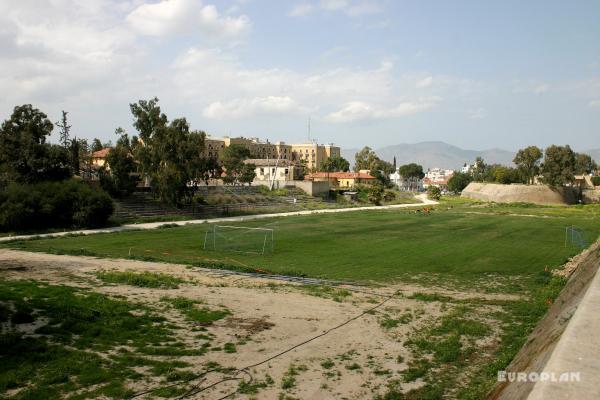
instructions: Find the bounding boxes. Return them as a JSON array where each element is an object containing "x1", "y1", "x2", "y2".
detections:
[{"x1": 2, "y1": 207, "x2": 600, "y2": 283}]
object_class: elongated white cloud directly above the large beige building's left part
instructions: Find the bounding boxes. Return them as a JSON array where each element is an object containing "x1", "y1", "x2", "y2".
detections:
[{"x1": 202, "y1": 96, "x2": 304, "y2": 119}]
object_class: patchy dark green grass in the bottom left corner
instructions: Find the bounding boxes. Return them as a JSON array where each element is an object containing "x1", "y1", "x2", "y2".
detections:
[{"x1": 0, "y1": 279, "x2": 197, "y2": 399}]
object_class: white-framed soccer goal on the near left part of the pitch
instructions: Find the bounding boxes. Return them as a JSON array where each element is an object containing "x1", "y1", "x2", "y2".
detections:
[{"x1": 204, "y1": 225, "x2": 275, "y2": 254}]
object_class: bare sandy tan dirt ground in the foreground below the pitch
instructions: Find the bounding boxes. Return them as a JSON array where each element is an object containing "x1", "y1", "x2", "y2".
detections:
[{"x1": 0, "y1": 249, "x2": 508, "y2": 399}]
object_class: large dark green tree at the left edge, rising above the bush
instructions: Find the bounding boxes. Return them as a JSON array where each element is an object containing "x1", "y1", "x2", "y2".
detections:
[{"x1": 0, "y1": 104, "x2": 71, "y2": 183}]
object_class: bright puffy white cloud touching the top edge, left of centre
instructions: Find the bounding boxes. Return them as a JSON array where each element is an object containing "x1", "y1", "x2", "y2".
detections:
[{"x1": 127, "y1": 0, "x2": 250, "y2": 37}]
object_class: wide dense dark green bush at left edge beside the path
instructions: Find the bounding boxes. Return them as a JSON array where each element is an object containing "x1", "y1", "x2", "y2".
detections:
[{"x1": 0, "y1": 180, "x2": 113, "y2": 231}]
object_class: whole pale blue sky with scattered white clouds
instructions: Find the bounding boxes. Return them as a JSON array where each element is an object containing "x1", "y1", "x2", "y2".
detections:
[{"x1": 0, "y1": 0, "x2": 600, "y2": 150}]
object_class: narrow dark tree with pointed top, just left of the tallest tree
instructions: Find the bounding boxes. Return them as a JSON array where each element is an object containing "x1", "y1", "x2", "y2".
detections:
[{"x1": 100, "y1": 128, "x2": 139, "y2": 198}]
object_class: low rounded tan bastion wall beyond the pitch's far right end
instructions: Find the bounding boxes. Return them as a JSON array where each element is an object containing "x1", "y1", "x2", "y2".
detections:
[{"x1": 461, "y1": 182, "x2": 577, "y2": 205}]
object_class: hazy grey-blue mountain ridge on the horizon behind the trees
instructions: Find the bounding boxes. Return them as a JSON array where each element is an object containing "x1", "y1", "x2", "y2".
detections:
[{"x1": 342, "y1": 142, "x2": 516, "y2": 169}]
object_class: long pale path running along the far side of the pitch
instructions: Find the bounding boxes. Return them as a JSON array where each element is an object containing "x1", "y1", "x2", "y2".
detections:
[{"x1": 0, "y1": 194, "x2": 439, "y2": 242}]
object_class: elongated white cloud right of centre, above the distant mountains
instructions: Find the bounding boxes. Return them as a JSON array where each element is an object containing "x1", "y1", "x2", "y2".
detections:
[{"x1": 327, "y1": 97, "x2": 441, "y2": 122}]
